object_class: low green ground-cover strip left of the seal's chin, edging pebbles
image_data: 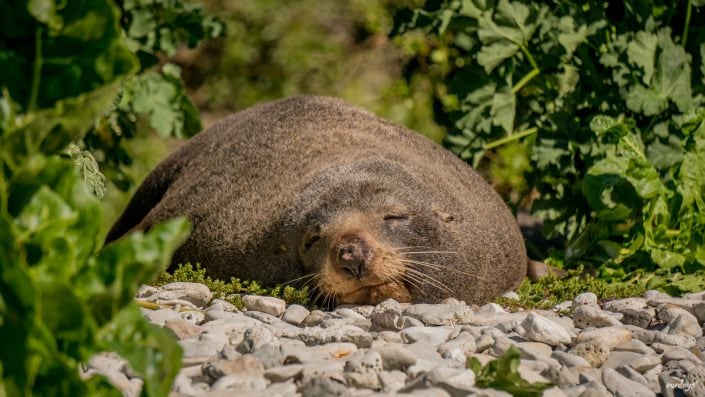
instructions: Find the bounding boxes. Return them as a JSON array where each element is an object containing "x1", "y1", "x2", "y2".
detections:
[{"x1": 152, "y1": 263, "x2": 310, "y2": 309}]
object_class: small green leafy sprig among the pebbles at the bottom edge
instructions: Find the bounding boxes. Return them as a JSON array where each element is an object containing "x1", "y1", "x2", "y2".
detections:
[{"x1": 467, "y1": 346, "x2": 551, "y2": 397}]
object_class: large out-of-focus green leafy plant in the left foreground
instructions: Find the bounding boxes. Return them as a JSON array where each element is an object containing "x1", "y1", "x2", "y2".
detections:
[{"x1": 0, "y1": 0, "x2": 220, "y2": 396}]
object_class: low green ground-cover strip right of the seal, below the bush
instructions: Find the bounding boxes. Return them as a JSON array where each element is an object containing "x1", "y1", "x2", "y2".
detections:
[{"x1": 495, "y1": 268, "x2": 646, "y2": 310}]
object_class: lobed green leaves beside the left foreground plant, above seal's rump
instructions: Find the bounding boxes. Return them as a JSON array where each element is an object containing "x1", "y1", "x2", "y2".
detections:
[{"x1": 78, "y1": 0, "x2": 225, "y2": 191}]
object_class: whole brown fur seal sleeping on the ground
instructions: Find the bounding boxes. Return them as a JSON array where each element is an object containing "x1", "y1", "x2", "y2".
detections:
[{"x1": 107, "y1": 96, "x2": 527, "y2": 304}]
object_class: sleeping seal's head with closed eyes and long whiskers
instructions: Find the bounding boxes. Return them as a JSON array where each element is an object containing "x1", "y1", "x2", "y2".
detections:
[{"x1": 288, "y1": 158, "x2": 482, "y2": 304}]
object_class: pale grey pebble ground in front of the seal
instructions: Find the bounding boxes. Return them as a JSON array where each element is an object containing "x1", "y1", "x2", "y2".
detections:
[{"x1": 85, "y1": 283, "x2": 705, "y2": 397}]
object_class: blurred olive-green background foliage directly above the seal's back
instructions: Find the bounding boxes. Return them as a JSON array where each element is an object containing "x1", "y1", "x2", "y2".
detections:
[{"x1": 177, "y1": 0, "x2": 444, "y2": 140}]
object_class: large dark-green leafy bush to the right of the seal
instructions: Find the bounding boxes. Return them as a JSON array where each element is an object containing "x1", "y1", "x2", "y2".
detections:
[{"x1": 392, "y1": 0, "x2": 705, "y2": 293}]
